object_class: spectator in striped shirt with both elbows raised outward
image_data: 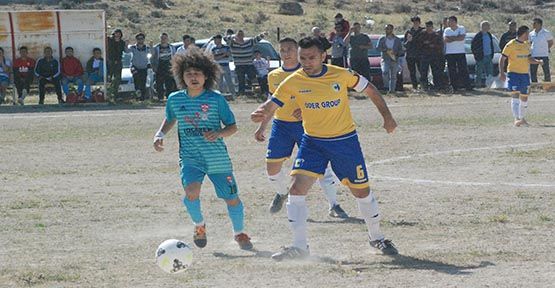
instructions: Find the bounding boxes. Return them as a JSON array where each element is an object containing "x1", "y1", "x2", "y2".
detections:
[{"x1": 224, "y1": 30, "x2": 266, "y2": 94}]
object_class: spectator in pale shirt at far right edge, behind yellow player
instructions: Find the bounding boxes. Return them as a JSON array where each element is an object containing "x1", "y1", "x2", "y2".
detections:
[{"x1": 530, "y1": 18, "x2": 553, "y2": 83}]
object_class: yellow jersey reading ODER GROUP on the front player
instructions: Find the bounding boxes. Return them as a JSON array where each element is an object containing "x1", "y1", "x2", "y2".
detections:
[{"x1": 272, "y1": 65, "x2": 368, "y2": 138}]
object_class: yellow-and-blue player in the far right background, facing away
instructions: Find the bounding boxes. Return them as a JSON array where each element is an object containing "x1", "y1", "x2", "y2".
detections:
[{"x1": 499, "y1": 26, "x2": 543, "y2": 127}]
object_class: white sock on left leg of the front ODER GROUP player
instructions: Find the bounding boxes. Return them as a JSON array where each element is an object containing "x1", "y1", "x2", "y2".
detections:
[{"x1": 287, "y1": 195, "x2": 308, "y2": 250}]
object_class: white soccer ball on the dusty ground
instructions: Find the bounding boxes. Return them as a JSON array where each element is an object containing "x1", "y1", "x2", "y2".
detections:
[{"x1": 156, "y1": 239, "x2": 193, "y2": 274}]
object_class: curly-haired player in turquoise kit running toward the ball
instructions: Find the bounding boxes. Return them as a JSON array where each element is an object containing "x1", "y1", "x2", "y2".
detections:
[{"x1": 154, "y1": 47, "x2": 253, "y2": 250}]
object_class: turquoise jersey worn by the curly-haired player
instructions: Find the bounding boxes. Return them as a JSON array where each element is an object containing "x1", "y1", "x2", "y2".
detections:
[{"x1": 166, "y1": 90, "x2": 235, "y2": 174}]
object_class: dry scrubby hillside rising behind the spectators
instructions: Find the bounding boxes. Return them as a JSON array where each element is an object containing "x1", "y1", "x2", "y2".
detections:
[{"x1": 4, "y1": 0, "x2": 555, "y2": 41}]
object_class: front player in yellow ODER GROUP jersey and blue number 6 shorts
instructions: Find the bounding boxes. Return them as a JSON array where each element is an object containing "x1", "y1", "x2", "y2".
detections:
[{"x1": 251, "y1": 37, "x2": 397, "y2": 261}]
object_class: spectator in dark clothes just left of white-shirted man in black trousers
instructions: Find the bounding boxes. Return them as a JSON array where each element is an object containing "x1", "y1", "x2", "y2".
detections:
[{"x1": 413, "y1": 21, "x2": 446, "y2": 90}]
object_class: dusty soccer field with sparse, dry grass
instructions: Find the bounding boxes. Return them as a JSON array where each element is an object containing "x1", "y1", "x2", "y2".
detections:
[{"x1": 0, "y1": 92, "x2": 555, "y2": 287}]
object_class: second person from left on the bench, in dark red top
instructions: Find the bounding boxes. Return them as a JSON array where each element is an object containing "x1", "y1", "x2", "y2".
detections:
[{"x1": 13, "y1": 46, "x2": 35, "y2": 105}]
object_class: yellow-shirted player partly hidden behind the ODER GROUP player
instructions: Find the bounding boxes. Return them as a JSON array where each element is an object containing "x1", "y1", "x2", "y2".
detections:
[{"x1": 254, "y1": 38, "x2": 349, "y2": 218}]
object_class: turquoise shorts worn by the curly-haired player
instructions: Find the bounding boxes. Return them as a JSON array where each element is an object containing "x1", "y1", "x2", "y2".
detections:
[{"x1": 181, "y1": 165, "x2": 239, "y2": 200}]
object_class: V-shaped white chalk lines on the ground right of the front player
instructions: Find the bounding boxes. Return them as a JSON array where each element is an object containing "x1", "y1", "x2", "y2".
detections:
[{"x1": 367, "y1": 142, "x2": 555, "y2": 188}]
